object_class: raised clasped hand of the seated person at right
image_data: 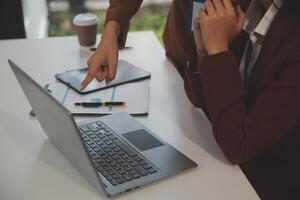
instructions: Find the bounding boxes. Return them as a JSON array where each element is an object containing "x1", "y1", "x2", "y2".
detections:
[{"x1": 199, "y1": 0, "x2": 245, "y2": 55}]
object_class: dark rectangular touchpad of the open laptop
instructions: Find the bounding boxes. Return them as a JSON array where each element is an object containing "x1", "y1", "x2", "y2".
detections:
[{"x1": 122, "y1": 129, "x2": 164, "y2": 151}]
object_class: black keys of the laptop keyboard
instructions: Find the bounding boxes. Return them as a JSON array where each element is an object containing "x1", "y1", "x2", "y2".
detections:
[{"x1": 79, "y1": 122, "x2": 157, "y2": 186}]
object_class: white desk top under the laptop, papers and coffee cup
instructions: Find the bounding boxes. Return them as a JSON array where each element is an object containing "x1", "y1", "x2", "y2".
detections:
[{"x1": 0, "y1": 32, "x2": 258, "y2": 200}]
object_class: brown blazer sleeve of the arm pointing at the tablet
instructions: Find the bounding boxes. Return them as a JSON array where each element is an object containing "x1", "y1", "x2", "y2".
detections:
[{"x1": 105, "y1": 0, "x2": 143, "y2": 47}]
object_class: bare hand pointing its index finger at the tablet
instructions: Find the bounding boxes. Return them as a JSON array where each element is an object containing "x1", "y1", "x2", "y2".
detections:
[{"x1": 80, "y1": 21, "x2": 120, "y2": 90}]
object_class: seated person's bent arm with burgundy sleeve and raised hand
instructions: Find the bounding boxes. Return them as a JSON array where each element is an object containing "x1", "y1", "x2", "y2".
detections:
[{"x1": 199, "y1": 0, "x2": 300, "y2": 164}]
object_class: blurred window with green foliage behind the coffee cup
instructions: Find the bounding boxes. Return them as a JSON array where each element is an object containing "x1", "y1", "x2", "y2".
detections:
[{"x1": 48, "y1": 0, "x2": 170, "y2": 41}]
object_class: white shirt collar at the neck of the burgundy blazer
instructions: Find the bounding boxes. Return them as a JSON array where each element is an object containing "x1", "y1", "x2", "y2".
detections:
[{"x1": 243, "y1": 0, "x2": 283, "y2": 43}]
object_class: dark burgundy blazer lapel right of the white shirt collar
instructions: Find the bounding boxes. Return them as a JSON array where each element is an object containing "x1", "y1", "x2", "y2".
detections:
[{"x1": 248, "y1": 7, "x2": 295, "y2": 91}]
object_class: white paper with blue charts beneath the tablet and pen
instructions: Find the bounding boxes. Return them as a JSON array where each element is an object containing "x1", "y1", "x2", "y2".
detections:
[{"x1": 49, "y1": 79, "x2": 150, "y2": 115}]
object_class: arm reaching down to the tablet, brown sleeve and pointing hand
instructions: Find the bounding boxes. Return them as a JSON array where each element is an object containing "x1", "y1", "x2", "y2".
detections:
[{"x1": 80, "y1": 0, "x2": 142, "y2": 90}]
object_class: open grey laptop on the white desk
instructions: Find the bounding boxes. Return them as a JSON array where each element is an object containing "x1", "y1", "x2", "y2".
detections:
[{"x1": 8, "y1": 60, "x2": 197, "y2": 197}]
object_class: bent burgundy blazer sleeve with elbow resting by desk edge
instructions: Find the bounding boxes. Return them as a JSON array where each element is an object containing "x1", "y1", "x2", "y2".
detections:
[{"x1": 199, "y1": 51, "x2": 300, "y2": 164}]
